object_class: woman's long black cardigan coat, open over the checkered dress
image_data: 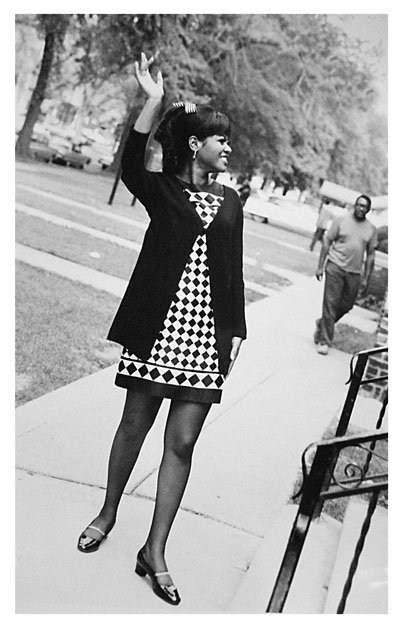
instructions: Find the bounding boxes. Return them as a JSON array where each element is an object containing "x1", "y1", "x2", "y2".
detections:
[{"x1": 107, "y1": 129, "x2": 246, "y2": 374}]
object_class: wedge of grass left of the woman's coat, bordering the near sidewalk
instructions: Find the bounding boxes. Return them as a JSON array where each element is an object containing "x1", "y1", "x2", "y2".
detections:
[{"x1": 15, "y1": 262, "x2": 120, "y2": 406}]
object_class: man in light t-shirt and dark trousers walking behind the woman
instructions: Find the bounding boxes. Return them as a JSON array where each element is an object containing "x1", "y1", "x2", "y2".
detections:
[{"x1": 314, "y1": 194, "x2": 378, "y2": 355}]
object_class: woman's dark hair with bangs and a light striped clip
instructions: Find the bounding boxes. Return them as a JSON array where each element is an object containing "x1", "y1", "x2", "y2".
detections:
[{"x1": 154, "y1": 105, "x2": 231, "y2": 175}]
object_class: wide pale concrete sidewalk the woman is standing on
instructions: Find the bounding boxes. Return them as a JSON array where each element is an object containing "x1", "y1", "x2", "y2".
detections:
[{"x1": 16, "y1": 253, "x2": 372, "y2": 614}]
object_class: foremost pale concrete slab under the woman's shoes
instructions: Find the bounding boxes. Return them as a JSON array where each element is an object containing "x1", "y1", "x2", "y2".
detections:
[{"x1": 16, "y1": 471, "x2": 259, "y2": 614}]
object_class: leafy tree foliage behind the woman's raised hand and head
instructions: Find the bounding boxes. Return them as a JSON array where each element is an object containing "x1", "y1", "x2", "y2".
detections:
[{"x1": 15, "y1": 14, "x2": 387, "y2": 193}]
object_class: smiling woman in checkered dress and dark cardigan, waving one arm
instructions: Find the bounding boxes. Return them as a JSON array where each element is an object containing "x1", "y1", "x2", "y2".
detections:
[{"x1": 78, "y1": 53, "x2": 246, "y2": 605}]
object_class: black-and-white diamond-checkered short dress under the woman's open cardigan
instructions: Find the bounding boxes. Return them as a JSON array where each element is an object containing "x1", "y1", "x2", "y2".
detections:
[{"x1": 116, "y1": 188, "x2": 224, "y2": 402}]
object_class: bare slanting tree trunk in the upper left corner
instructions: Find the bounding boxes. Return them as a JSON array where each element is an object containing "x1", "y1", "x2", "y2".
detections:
[{"x1": 15, "y1": 31, "x2": 56, "y2": 158}]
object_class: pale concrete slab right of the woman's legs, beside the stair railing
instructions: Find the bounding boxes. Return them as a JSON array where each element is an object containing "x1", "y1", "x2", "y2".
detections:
[{"x1": 136, "y1": 282, "x2": 349, "y2": 536}]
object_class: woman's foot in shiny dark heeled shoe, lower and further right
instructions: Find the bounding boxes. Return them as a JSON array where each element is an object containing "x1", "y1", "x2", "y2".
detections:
[{"x1": 135, "y1": 546, "x2": 181, "y2": 605}]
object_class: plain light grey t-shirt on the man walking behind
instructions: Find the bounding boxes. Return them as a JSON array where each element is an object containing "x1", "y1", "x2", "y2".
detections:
[{"x1": 325, "y1": 213, "x2": 378, "y2": 273}]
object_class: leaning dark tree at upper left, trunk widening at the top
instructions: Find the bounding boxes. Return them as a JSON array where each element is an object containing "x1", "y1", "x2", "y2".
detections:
[{"x1": 15, "y1": 14, "x2": 70, "y2": 158}]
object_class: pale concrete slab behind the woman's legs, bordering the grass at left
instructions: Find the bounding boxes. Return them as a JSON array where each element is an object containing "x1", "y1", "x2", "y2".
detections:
[{"x1": 16, "y1": 334, "x2": 278, "y2": 493}]
